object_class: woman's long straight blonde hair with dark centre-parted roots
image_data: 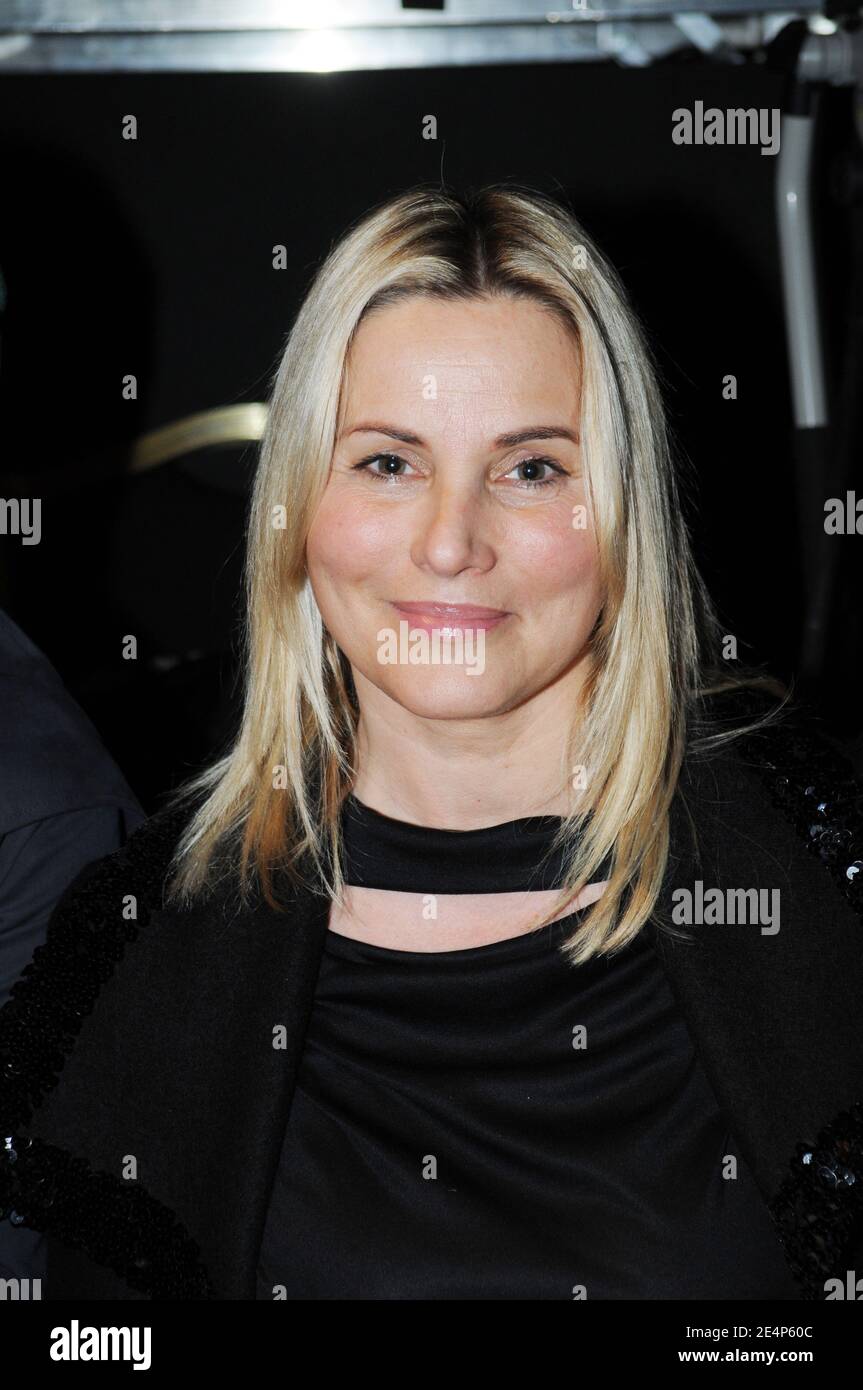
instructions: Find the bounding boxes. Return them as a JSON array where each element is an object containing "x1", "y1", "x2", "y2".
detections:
[{"x1": 159, "y1": 183, "x2": 781, "y2": 963}]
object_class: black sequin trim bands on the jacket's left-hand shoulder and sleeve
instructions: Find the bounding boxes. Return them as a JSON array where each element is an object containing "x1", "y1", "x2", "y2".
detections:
[{"x1": 0, "y1": 809, "x2": 215, "y2": 1300}]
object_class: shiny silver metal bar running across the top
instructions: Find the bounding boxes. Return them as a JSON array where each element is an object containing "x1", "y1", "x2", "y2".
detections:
[{"x1": 0, "y1": 0, "x2": 820, "y2": 72}]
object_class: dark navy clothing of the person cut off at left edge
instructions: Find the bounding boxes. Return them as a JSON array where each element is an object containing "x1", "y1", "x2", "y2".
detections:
[{"x1": 0, "y1": 609, "x2": 146, "y2": 1277}]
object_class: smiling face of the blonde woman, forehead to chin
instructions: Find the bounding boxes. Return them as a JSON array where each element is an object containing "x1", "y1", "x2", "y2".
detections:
[{"x1": 306, "y1": 296, "x2": 602, "y2": 719}]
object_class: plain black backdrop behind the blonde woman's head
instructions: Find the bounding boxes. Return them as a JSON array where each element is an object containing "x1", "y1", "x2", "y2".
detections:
[{"x1": 0, "y1": 57, "x2": 863, "y2": 810}]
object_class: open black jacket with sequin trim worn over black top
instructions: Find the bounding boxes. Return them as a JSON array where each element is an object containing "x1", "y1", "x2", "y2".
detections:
[{"x1": 0, "y1": 695, "x2": 863, "y2": 1300}]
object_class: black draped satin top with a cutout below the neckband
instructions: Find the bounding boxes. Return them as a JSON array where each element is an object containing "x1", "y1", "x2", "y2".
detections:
[{"x1": 257, "y1": 798, "x2": 800, "y2": 1300}]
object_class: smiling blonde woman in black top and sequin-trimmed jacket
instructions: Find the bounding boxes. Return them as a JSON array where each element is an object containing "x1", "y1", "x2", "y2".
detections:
[{"x1": 0, "y1": 186, "x2": 863, "y2": 1300}]
